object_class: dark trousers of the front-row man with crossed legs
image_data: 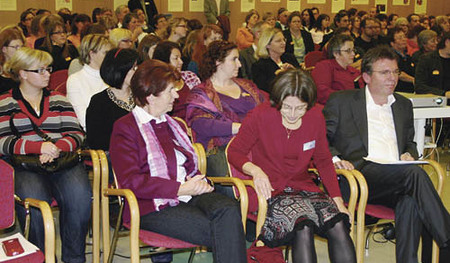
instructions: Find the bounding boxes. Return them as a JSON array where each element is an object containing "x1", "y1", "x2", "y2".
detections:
[{"x1": 361, "y1": 162, "x2": 450, "y2": 263}]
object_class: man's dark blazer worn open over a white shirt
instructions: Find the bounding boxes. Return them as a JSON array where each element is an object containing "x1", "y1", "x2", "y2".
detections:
[{"x1": 323, "y1": 88, "x2": 418, "y2": 169}]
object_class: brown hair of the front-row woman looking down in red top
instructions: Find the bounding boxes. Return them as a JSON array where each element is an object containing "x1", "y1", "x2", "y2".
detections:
[{"x1": 270, "y1": 69, "x2": 317, "y2": 110}]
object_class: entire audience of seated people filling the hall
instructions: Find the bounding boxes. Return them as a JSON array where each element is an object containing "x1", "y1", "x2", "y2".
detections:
[{"x1": 0, "y1": 3, "x2": 450, "y2": 263}]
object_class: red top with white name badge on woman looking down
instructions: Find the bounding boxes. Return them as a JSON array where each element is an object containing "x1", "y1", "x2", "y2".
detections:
[{"x1": 228, "y1": 103, "x2": 341, "y2": 200}]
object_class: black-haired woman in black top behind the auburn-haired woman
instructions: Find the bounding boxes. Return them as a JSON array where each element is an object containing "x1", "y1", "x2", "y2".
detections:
[{"x1": 86, "y1": 48, "x2": 138, "y2": 151}]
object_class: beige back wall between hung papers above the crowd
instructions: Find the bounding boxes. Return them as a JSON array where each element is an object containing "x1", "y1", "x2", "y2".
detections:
[{"x1": 0, "y1": 0, "x2": 450, "y2": 39}]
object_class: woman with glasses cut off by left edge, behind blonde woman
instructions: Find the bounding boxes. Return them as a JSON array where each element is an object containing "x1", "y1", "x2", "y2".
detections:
[{"x1": 0, "y1": 26, "x2": 25, "y2": 94}]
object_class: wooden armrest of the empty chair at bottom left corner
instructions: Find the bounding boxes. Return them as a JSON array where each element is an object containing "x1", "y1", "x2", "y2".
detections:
[{"x1": 24, "y1": 198, "x2": 55, "y2": 263}]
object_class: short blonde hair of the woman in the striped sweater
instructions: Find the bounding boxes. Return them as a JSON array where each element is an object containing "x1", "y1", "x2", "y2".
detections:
[{"x1": 4, "y1": 47, "x2": 53, "y2": 80}]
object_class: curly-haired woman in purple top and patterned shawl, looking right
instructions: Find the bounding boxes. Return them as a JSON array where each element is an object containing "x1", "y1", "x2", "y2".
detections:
[{"x1": 186, "y1": 41, "x2": 264, "y2": 196}]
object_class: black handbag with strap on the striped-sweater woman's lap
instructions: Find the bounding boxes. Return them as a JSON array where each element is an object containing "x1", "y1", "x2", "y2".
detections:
[{"x1": 9, "y1": 112, "x2": 83, "y2": 174}]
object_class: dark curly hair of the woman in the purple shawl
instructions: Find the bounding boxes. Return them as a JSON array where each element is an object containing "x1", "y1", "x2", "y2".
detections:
[{"x1": 199, "y1": 40, "x2": 237, "y2": 81}]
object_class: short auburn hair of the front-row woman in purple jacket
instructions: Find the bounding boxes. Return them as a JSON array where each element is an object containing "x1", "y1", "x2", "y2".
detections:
[{"x1": 131, "y1": 59, "x2": 181, "y2": 107}]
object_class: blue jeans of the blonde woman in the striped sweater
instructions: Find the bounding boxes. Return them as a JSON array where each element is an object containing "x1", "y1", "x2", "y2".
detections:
[{"x1": 14, "y1": 164, "x2": 92, "y2": 263}]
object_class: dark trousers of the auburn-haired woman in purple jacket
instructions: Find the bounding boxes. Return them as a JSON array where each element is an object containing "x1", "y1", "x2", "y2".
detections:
[{"x1": 141, "y1": 193, "x2": 247, "y2": 263}]
